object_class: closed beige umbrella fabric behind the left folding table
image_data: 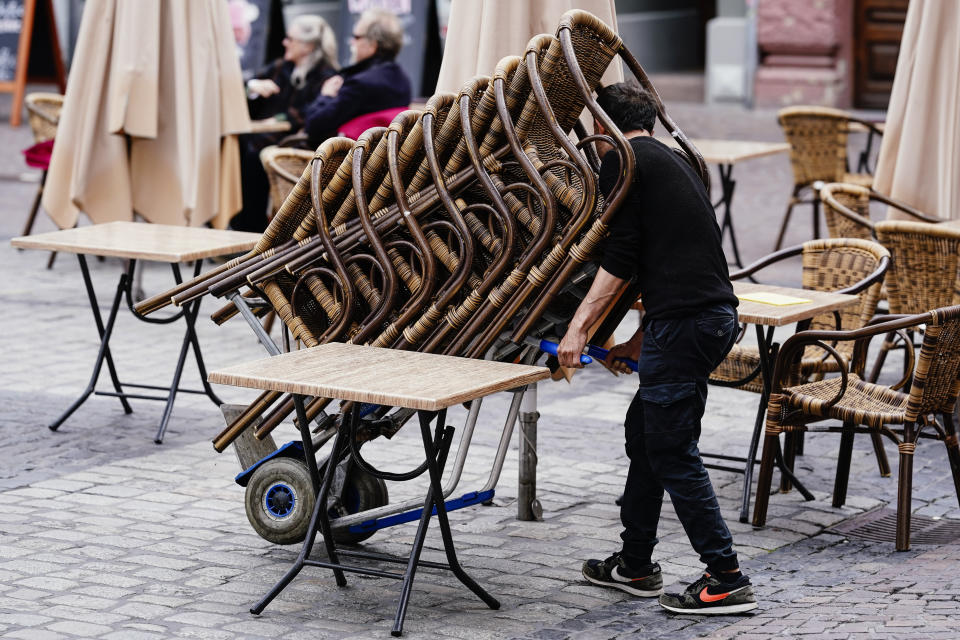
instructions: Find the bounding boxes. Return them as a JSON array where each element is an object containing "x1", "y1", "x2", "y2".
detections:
[{"x1": 43, "y1": 0, "x2": 250, "y2": 228}]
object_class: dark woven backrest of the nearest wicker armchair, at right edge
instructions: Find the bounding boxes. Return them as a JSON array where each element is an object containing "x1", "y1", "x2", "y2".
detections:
[{"x1": 906, "y1": 306, "x2": 960, "y2": 422}]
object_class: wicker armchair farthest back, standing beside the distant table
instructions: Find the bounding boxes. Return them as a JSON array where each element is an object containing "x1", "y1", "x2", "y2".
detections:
[{"x1": 774, "y1": 107, "x2": 881, "y2": 250}]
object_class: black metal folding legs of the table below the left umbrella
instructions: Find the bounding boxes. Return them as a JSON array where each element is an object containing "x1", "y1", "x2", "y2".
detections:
[{"x1": 48, "y1": 253, "x2": 223, "y2": 444}]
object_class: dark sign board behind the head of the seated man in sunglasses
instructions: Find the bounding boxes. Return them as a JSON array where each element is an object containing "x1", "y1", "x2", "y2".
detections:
[{"x1": 337, "y1": 0, "x2": 440, "y2": 96}]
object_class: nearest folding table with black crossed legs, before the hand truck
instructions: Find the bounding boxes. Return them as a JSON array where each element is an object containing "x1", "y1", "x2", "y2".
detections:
[{"x1": 210, "y1": 342, "x2": 550, "y2": 636}]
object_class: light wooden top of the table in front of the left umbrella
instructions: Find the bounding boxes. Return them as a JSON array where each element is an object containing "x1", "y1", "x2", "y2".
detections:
[{"x1": 10, "y1": 222, "x2": 260, "y2": 262}]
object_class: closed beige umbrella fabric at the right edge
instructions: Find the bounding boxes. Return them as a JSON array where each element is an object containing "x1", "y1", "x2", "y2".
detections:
[{"x1": 873, "y1": 0, "x2": 960, "y2": 218}]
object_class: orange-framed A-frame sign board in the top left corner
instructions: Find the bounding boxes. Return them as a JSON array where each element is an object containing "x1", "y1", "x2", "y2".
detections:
[{"x1": 0, "y1": 0, "x2": 67, "y2": 127}]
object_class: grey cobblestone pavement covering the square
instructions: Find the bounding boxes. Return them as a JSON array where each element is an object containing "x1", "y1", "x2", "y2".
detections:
[{"x1": 0, "y1": 91, "x2": 960, "y2": 640}]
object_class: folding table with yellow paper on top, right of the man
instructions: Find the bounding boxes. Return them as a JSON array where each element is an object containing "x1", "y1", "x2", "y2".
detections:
[{"x1": 701, "y1": 282, "x2": 859, "y2": 522}]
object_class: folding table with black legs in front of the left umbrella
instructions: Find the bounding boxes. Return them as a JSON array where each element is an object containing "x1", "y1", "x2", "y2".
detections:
[{"x1": 10, "y1": 222, "x2": 260, "y2": 444}]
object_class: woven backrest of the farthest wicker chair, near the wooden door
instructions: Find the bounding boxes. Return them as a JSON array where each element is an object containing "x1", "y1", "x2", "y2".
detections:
[{"x1": 777, "y1": 107, "x2": 849, "y2": 186}]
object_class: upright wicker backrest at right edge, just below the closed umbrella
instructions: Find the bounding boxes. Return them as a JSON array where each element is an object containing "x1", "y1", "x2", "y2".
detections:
[{"x1": 876, "y1": 220, "x2": 960, "y2": 313}]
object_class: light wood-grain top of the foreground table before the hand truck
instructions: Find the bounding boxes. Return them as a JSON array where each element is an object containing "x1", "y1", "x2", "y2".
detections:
[{"x1": 208, "y1": 342, "x2": 550, "y2": 411}]
